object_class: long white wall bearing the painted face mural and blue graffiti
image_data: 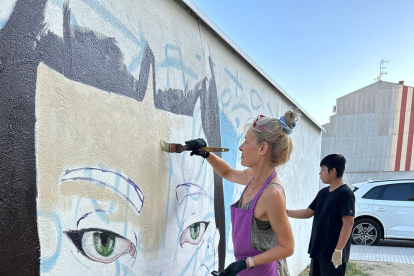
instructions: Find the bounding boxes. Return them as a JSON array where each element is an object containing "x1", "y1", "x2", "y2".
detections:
[{"x1": 0, "y1": 0, "x2": 321, "y2": 275}]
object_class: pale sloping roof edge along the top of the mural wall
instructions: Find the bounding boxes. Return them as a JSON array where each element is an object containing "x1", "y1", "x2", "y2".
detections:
[{"x1": 180, "y1": 0, "x2": 325, "y2": 131}]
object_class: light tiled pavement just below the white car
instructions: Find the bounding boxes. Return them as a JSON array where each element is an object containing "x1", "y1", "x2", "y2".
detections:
[{"x1": 350, "y1": 240, "x2": 414, "y2": 264}]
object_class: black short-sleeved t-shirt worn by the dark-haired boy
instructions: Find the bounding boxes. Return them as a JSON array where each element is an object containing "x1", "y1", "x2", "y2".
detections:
[{"x1": 308, "y1": 184, "x2": 355, "y2": 263}]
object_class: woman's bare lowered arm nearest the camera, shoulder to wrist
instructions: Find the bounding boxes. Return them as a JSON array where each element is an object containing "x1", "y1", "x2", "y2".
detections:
[{"x1": 249, "y1": 186, "x2": 295, "y2": 266}]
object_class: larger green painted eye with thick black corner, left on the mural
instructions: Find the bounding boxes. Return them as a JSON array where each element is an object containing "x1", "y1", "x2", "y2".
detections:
[{"x1": 64, "y1": 228, "x2": 136, "y2": 263}]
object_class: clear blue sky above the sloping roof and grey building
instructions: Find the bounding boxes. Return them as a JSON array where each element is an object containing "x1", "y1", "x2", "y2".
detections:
[{"x1": 193, "y1": 0, "x2": 414, "y2": 124}]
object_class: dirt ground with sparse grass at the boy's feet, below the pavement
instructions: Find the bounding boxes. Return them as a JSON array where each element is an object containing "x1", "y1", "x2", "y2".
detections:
[{"x1": 298, "y1": 261, "x2": 414, "y2": 276}]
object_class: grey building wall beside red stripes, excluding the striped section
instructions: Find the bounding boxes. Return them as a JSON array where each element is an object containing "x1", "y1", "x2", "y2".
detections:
[{"x1": 321, "y1": 82, "x2": 398, "y2": 172}]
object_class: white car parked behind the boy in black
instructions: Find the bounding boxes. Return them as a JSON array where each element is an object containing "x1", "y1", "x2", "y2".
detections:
[{"x1": 351, "y1": 179, "x2": 414, "y2": 245}]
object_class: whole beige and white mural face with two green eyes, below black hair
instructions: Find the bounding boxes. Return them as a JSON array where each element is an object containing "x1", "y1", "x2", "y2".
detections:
[{"x1": 36, "y1": 64, "x2": 220, "y2": 275}]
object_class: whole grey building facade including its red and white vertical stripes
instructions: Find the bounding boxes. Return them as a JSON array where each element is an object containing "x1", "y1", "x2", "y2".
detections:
[{"x1": 320, "y1": 81, "x2": 414, "y2": 187}]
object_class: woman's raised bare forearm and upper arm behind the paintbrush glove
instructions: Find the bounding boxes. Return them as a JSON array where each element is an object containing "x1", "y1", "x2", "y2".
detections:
[{"x1": 206, "y1": 152, "x2": 253, "y2": 185}]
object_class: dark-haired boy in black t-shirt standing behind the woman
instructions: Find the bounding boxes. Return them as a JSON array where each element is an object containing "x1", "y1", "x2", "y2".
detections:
[{"x1": 286, "y1": 154, "x2": 355, "y2": 276}]
